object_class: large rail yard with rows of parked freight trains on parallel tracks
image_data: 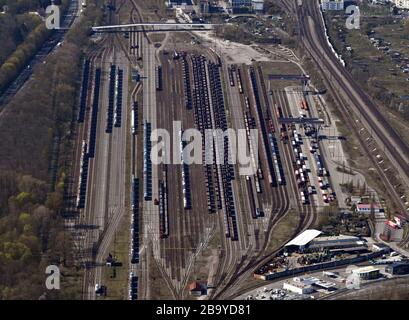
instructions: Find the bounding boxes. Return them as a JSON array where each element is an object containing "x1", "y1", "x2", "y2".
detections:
[{"x1": 56, "y1": 0, "x2": 407, "y2": 300}]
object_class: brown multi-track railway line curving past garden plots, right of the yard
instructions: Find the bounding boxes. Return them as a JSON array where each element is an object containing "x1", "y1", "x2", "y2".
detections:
[{"x1": 280, "y1": 0, "x2": 409, "y2": 250}]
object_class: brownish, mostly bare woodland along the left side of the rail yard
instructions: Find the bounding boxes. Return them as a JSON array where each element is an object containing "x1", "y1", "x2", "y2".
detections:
[{"x1": 0, "y1": 0, "x2": 102, "y2": 299}]
